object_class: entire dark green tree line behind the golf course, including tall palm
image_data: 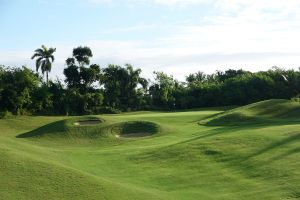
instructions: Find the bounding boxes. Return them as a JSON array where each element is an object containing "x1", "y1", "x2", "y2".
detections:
[{"x1": 0, "y1": 46, "x2": 300, "y2": 115}]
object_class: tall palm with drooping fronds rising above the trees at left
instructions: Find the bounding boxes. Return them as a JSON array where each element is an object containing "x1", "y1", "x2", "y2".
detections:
[{"x1": 31, "y1": 45, "x2": 56, "y2": 84}]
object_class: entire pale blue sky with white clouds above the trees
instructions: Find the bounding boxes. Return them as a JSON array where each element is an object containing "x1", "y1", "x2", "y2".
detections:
[{"x1": 0, "y1": 0, "x2": 300, "y2": 80}]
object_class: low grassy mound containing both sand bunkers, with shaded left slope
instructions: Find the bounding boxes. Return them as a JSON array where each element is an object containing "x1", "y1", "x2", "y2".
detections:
[{"x1": 16, "y1": 116, "x2": 159, "y2": 143}]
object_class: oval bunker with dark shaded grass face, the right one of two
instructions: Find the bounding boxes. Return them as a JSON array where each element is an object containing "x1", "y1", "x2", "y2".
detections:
[{"x1": 113, "y1": 121, "x2": 159, "y2": 138}]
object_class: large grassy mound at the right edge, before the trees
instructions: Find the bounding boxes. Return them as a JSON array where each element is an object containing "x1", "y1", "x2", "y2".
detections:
[{"x1": 200, "y1": 99, "x2": 300, "y2": 125}]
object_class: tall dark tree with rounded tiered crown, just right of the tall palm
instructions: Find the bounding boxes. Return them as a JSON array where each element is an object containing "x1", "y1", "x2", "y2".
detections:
[{"x1": 64, "y1": 46, "x2": 103, "y2": 114}]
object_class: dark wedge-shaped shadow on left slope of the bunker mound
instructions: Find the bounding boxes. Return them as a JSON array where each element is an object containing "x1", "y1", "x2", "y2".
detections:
[{"x1": 16, "y1": 120, "x2": 66, "y2": 138}]
